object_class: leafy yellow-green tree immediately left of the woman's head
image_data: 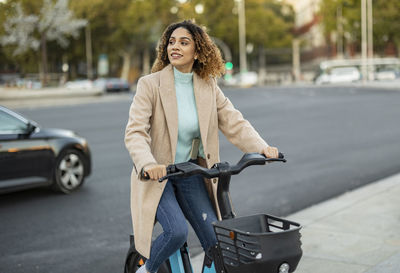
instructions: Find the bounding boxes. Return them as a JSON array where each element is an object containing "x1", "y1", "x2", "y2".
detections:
[{"x1": 71, "y1": 0, "x2": 176, "y2": 81}]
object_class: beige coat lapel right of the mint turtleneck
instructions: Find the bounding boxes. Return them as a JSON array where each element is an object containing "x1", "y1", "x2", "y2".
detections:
[{"x1": 193, "y1": 73, "x2": 213, "y2": 152}]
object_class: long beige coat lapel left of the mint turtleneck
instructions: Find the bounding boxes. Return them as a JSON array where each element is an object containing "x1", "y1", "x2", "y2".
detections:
[{"x1": 159, "y1": 65, "x2": 178, "y2": 162}]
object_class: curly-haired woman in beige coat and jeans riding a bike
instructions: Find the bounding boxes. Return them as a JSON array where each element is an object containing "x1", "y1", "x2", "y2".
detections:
[{"x1": 125, "y1": 21, "x2": 278, "y2": 273}]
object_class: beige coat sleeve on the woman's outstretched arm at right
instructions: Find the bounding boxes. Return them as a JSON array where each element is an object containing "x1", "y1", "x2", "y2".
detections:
[{"x1": 215, "y1": 84, "x2": 268, "y2": 153}]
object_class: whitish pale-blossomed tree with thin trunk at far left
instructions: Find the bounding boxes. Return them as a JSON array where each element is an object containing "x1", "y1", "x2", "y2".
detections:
[{"x1": 1, "y1": 0, "x2": 86, "y2": 85}]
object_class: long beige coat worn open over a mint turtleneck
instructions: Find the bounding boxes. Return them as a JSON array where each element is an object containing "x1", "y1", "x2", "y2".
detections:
[{"x1": 125, "y1": 65, "x2": 267, "y2": 257}]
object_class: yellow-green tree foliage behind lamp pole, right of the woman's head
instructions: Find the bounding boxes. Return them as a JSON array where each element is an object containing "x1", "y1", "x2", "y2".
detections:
[{"x1": 178, "y1": 0, "x2": 294, "y2": 71}]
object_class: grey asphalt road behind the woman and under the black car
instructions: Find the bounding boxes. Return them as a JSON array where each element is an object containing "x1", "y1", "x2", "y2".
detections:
[{"x1": 0, "y1": 84, "x2": 400, "y2": 273}]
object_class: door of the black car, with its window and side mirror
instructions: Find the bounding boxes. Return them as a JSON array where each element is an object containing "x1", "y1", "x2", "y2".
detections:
[{"x1": 0, "y1": 110, "x2": 54, "y2": 188}]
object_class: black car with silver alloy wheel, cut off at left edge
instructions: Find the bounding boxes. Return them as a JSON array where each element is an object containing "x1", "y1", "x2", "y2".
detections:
[{"x1": 0, "y1": 106, "x2": 91, "y2": 193}]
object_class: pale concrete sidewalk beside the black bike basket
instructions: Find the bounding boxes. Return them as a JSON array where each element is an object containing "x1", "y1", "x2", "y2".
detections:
[{"x1": 193, "y1": 174, "x2": 400, "y2": 273}]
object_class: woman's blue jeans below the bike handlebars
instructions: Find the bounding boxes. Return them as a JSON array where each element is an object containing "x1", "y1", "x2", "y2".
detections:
[{"x1": 146, "y1": 175, "x2": 217, "y2": 273}]
